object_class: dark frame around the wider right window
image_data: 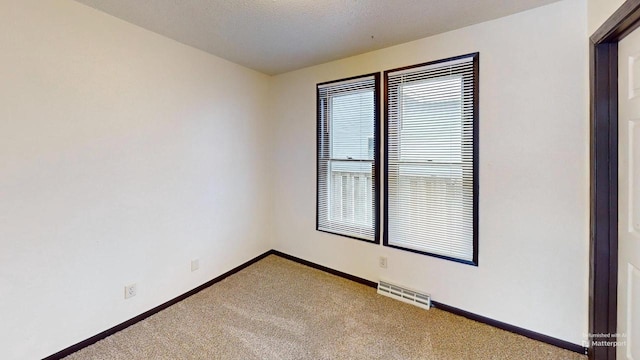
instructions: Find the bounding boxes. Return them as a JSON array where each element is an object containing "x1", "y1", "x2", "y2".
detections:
[{"x1": 383, "y1": 52, "x2": 480, "y2": 266}]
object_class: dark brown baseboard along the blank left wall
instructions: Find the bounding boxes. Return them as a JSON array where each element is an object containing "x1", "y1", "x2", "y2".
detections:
[{"x1": 43, "y1": 250, "x2": 274, "y2": 360}]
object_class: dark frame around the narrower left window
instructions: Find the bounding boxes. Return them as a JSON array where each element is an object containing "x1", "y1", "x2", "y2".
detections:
[{"x1": 316, "y1": 72, "x2": 382, "y2": 244}]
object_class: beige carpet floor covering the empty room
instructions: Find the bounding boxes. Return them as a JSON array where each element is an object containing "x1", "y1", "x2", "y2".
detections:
[{"x1": 66, "y1": 255, "x2": 586, "y2": 360}]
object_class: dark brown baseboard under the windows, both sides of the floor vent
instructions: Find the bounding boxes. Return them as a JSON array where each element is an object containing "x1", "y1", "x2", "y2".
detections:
[{"x1": 272, "y1": 250, "x2": 588, "y2": 354}]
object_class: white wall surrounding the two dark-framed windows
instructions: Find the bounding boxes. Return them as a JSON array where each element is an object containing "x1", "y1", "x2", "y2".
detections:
[{"x1": 271, "y1": 0, "x2": 589, "y2": 344}]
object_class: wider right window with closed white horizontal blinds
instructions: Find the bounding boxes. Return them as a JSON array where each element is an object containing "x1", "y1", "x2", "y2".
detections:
[{"x1": 384, "y1": 53, "x2": 479, "y2": 265}]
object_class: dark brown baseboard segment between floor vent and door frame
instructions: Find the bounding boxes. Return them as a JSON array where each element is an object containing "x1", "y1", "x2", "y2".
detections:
[{"x1": 431, "y1": 300, "x2": 588, "y2": 354}]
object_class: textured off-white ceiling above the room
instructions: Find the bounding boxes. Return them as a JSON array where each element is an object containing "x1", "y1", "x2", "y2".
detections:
[{"x1": 76, "y1": 0, "x2": 557, "y2": 75}]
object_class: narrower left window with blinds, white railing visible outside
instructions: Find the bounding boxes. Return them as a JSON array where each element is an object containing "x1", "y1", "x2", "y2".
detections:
[{"x1": 316, "y1": 74, "x2": 380, "y2": 243}]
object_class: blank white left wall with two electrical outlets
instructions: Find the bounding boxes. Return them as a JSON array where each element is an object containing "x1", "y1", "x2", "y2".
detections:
[{"x1": 0, "y1": 0, "x2": 270, "y2": 359}]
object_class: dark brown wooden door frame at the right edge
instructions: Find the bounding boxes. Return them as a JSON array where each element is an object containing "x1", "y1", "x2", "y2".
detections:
[{"x1": 589, "y1": 0, "x2": 640, "y2": 360}]
